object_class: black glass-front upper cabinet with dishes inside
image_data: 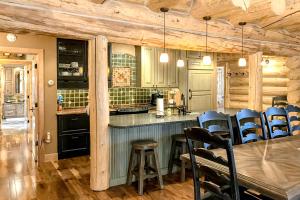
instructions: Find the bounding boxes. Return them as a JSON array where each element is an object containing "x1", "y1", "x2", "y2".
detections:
[{"x1": 57, "y1": 38, "x2": 88, "y2": 89}]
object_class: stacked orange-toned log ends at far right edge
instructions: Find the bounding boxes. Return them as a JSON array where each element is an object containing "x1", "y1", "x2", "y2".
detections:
[{"x1": 286, "y1": 56, "x2": 300, "y2": 106}]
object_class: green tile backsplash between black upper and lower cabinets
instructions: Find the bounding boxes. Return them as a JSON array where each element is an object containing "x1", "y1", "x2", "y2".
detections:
[{"x1": 57, "y1": 89, "x2": 88, "y2": 108}]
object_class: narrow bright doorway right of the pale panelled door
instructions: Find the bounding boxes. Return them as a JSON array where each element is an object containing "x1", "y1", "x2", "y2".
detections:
[{"x1": 217, "y1": 66, "x2": 225, "y2": 109}]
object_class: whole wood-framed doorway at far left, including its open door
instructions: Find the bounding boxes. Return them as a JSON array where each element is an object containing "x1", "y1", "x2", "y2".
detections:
[{"x1": 0, "y1": 47, "x2": 44, "y2": 162}]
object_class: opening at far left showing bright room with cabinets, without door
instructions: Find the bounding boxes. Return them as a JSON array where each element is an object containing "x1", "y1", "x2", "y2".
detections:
[{"x1": 0, "y1": 61, "x2": 27, "y2": 135}]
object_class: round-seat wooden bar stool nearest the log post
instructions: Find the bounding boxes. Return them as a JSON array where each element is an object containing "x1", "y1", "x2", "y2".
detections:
[{"x1": 127, "y1": 140, "x2": 163, "y2": 195}]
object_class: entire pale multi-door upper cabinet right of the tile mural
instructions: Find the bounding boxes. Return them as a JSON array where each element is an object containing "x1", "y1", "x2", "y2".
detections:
[{"x1": 141, "y1": 47, "x2": 178, "y2": 87}]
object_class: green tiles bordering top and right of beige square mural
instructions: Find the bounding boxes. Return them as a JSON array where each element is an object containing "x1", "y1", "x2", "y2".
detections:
[{"x1": 111, "y1": 53, "x2": 136, "y2": 87}]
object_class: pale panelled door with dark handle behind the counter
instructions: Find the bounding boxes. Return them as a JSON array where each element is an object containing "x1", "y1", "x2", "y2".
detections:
[{"x1": 188, "y1": 70, "x2": 213, "y2": 112}]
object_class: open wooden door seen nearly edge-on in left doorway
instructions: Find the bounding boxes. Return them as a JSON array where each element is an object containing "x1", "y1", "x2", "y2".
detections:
[{"x1": 27, "y1": 63, "x2": 39, "y2": 162}]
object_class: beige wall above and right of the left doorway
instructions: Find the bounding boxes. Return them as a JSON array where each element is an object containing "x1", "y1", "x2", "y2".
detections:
[{"x1": 0, "y1": 33, "x2": 57, "y2": 154}]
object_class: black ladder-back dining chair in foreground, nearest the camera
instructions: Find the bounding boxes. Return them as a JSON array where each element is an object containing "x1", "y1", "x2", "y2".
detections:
[{"x1": 184, "y1": 127, "x2": 240, "y2": 200}]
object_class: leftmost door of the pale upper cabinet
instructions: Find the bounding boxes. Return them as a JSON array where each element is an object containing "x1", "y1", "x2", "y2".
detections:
[{"x1": 141, "y1": 47, "x2": 155, "y2": 87}]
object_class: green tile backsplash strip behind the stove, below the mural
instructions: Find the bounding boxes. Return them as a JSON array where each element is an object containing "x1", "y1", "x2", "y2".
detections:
[{"x1": 109, "y1": 87, "x2": 170, "y2": 106}]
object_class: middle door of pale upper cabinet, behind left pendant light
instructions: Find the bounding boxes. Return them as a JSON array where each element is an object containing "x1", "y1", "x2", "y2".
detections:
[{"x1": 155, "y1": 49, "x2": 170, "y2": 87}]
